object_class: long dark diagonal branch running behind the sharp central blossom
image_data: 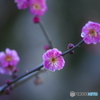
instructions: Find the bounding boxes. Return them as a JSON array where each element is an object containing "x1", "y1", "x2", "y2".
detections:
[{"x1": 0, "y1": 40, "x2": 83, "y2": 95}]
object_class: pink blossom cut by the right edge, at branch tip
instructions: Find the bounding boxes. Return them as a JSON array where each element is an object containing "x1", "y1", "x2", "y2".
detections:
[{"x1": 81, "y1": 21, "x2": 100, "y2": 44}]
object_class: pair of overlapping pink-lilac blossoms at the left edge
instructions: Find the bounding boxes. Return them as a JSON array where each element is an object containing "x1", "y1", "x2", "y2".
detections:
[{"x1": 0, "y1": 48, "x2": 20, "y2": 75}]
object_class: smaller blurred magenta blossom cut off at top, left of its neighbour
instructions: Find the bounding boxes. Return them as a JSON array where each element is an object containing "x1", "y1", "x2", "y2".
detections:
[{"x1": 14, "y1": 0, "x2": 29, "y2": 9}]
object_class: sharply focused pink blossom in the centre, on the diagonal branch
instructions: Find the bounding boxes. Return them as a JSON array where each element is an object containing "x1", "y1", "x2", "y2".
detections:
[{"x1": 43, "y1": 48, "x2": 65, "y2": 71}]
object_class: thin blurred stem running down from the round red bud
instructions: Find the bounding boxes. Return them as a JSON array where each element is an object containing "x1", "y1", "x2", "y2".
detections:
[{"x1": 39, "y1": 21, "x2": 54, "y2": 48}]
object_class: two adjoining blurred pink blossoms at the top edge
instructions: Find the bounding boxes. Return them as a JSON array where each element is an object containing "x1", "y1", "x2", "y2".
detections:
[{"x1": 15, "y1": 0, "x2": 47, "y2": 16}]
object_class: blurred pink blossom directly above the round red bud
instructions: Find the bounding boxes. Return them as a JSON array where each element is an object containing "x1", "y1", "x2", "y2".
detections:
[{"x1": 29, "y1": 0, "x2": 47, "y2": 16}]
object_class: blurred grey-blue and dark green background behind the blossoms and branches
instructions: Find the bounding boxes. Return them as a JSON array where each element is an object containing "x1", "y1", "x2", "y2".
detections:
[{"x1": 0, "y1": 0, "x2": 100, "y2": 100}]
